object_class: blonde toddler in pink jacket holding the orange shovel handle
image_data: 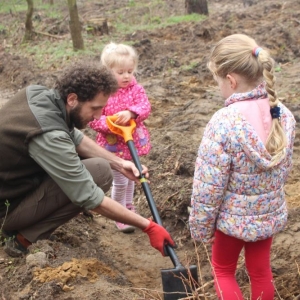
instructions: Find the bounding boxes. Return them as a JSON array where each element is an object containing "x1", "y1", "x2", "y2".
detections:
[{"x1": 89, "y1": 43, "x2": 151, "y2": 233}]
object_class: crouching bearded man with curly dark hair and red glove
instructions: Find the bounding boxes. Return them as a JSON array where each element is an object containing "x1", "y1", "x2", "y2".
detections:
[{"x1": 0, "y1": 62, "x2": 174, "y2": 256}]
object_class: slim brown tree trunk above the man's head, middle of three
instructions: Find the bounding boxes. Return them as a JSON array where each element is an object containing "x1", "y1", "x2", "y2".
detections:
[{"x1": 68, "y1": 0, "x2": 84, "y2": 51}]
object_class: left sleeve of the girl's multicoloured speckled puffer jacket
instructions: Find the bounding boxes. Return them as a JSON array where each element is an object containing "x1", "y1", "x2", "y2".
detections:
[{"x1": 189, "y1": 113, "x2": 230, "y2": 242}]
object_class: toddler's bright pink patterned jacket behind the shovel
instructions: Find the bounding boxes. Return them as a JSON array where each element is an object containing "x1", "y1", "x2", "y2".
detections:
[{"x1": 89, "y1": 79, "x2": 151, "y2": 160}]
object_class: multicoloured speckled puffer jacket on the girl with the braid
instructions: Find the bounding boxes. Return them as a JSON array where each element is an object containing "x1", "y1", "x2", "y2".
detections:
[{"x1": 189, "y1": 84, "x2": 295, "y2": 242}]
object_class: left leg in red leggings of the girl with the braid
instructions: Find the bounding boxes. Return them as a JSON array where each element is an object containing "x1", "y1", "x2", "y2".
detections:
[{"x1": 212, "y1": 230, "x2": 244, "y2": 300}]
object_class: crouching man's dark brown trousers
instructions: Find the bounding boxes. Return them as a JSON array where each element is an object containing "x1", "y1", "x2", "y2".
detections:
[{"x1": 3, "y1": 158, "x2": 113, "y2": 243}]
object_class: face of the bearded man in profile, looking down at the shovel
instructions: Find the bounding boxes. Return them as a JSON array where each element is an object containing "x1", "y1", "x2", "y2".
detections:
[{"x1": 69, "y1": 93, "x2": 109, "y2": 129}]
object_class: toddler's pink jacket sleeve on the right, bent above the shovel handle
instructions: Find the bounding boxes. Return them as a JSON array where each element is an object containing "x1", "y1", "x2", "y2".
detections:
[{"x1": 127, "y1": 84, "x2": 151, "y2": 122}]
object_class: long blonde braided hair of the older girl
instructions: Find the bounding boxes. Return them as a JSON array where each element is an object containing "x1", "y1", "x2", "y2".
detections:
[{"x1": 208, "y1": 34, "x2": 287, "y2": 167}]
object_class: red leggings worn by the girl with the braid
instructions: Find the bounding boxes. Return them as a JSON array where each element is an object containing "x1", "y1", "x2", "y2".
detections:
[{"x1": 212, "y1": 230, "x2": 274, "y2": 300}]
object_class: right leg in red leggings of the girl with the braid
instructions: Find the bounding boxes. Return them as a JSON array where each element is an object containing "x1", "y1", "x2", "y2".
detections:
[{"x1": 245, "y1": 238, "x2": 274, "y2": 300}]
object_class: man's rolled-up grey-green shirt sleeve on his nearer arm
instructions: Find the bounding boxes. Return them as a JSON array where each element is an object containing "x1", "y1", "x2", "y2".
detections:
[{"x1": 28, "y1": 130, "x2": 104, "y2": 209}]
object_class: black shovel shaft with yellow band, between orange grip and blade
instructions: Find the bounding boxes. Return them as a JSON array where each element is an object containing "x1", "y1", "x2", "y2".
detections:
[{"x1": 127, "y1": 140, "x2": 182, "y2": 268}]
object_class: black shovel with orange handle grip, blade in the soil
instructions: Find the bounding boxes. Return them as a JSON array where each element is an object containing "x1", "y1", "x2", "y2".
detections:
[{"x1": 106, "y1": 116, "x2": 199, "y2": 300}]
